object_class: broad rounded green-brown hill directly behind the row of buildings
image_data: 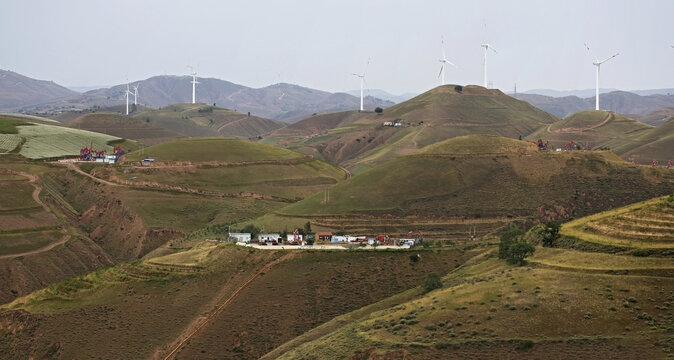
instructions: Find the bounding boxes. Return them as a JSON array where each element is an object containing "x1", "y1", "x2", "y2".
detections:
[{"x1": 277, "y1": 135, "x2": 674, "y2": 242}]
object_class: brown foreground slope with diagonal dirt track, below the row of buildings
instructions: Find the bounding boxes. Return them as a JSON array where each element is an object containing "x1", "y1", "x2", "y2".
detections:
[{"x1": 0, "y1": 242, "x2": 473, "y2": 359}]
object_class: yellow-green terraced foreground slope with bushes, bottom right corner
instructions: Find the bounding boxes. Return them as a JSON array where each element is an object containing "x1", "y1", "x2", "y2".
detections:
[{"x1": 263, "y1": 198, "x2": 674, "y2": 359}]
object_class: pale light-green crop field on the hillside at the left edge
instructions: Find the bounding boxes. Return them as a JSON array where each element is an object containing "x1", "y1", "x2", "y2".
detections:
[{"x1": 0, "y1": 118, "x2": 139, "y2": 159}]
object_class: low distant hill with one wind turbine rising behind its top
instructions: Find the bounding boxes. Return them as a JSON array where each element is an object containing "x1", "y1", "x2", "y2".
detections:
[{"x1": 133, "y1": 104, "x2": 285, "y2": 139}]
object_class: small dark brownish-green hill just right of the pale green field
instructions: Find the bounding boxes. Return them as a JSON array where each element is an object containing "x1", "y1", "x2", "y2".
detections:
[{"x1": 66, "y1": 112, "x2": 183, "y2": 145}]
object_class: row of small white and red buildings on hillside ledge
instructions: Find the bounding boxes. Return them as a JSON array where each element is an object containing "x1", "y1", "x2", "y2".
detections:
[{"x1": 228, "y1": 232, "x2": 423, "y2": 246}]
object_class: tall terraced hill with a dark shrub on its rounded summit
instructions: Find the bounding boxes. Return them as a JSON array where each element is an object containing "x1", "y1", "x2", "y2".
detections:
[{"x1": 266, "y1": 85, "x2": 558, "y2": 173}]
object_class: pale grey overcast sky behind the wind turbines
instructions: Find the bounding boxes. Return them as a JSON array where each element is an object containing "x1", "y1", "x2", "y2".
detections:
[{"x1": 0, "y1": 0, "x2": 674, "y2": 94}]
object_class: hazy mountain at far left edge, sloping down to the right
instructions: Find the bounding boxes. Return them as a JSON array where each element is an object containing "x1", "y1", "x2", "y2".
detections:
[{"x1": 0, "y1": 70, "x2": 78, "y2": 112}]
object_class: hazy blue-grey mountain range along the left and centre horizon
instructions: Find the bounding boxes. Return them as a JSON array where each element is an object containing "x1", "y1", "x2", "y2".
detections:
[{"x1": 0, "y1": 71, "x2": 394, "y2": 122}]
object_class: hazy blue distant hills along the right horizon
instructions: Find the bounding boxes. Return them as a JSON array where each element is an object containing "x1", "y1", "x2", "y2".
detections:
[{"x1": 516, "y1": 91, "x2": 674, "y2": 117}]
